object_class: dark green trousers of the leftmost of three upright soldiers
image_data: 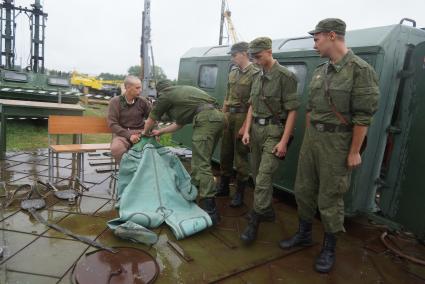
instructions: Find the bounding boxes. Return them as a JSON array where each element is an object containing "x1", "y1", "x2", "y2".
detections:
[{"x1": 220, "y1": 112, "x2": 249, "y2": 181}]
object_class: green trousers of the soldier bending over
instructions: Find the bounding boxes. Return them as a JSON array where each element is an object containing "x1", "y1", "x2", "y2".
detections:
[{"x1": 191, "y1": 109, "x2": 224, "y2": 198}]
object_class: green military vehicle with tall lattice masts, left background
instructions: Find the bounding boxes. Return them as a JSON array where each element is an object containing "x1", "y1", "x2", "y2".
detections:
[{"x1": 0, "y1": 0, "x2": 80, "y2": 104}]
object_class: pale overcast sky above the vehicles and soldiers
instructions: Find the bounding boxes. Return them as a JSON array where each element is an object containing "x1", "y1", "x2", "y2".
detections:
[{"x1": 15, "y1": 0, "x2": 425, "y2": 79}]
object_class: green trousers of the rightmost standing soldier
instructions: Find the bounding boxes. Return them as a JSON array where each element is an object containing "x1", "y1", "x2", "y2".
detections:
[{"x1": 295, "y1": 127, "x2": 352, "y2": 233}]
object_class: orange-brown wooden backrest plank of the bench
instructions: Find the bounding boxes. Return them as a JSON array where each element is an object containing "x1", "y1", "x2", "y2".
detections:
[{"x1": 48, "y1": 115, "x2": 112, "y2": 134}]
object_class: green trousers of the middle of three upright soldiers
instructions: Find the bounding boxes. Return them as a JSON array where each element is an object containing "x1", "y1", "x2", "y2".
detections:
[{"x1": 250, "y1": 123, "x2": 283, "y2": 214}]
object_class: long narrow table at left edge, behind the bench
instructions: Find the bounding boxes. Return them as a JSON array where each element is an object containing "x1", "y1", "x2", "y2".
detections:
[{"x1": 0, "y1": 99, "x2": 84, "y2": 160}]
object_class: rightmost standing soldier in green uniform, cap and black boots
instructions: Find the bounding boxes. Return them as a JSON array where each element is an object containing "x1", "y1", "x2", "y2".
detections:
[{"x1": 279, "y1": 18, "x2": 379, "y2": 272}]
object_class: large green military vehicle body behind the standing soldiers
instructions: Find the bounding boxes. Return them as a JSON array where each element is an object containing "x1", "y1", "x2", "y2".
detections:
[{"x1": 174, "y1": 19, "x2": 425, "y2": 239}]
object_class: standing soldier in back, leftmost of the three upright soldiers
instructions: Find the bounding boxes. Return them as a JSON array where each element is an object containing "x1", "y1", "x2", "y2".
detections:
[{"x1": 217, "y1": 42, "x2": 258, "y2": 207}]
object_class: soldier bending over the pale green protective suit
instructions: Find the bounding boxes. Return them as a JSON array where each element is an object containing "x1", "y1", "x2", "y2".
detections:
[{"x1": 142, "y1": 80, "x2": 224, "y2": 224}]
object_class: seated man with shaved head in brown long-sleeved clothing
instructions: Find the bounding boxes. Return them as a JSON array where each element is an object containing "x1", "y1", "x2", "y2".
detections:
[{"x1": 108, "y1": 76, "x2": 152, "y2": 163}]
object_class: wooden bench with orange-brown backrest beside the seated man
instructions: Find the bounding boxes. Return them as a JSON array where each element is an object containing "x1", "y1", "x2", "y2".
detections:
[{"x1": 48, "y1": 115, "x2": 112, "y2": 182}]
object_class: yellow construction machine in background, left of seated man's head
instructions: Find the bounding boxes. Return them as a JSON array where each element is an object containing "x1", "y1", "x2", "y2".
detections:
[{"x1": 71, "y1": 71, "x2": 123, "y2": 98}]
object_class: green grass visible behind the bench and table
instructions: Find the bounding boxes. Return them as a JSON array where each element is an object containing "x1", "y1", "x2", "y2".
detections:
[{"x1": 6, "y1": 102, "x2": 174, "y2": 151}]
